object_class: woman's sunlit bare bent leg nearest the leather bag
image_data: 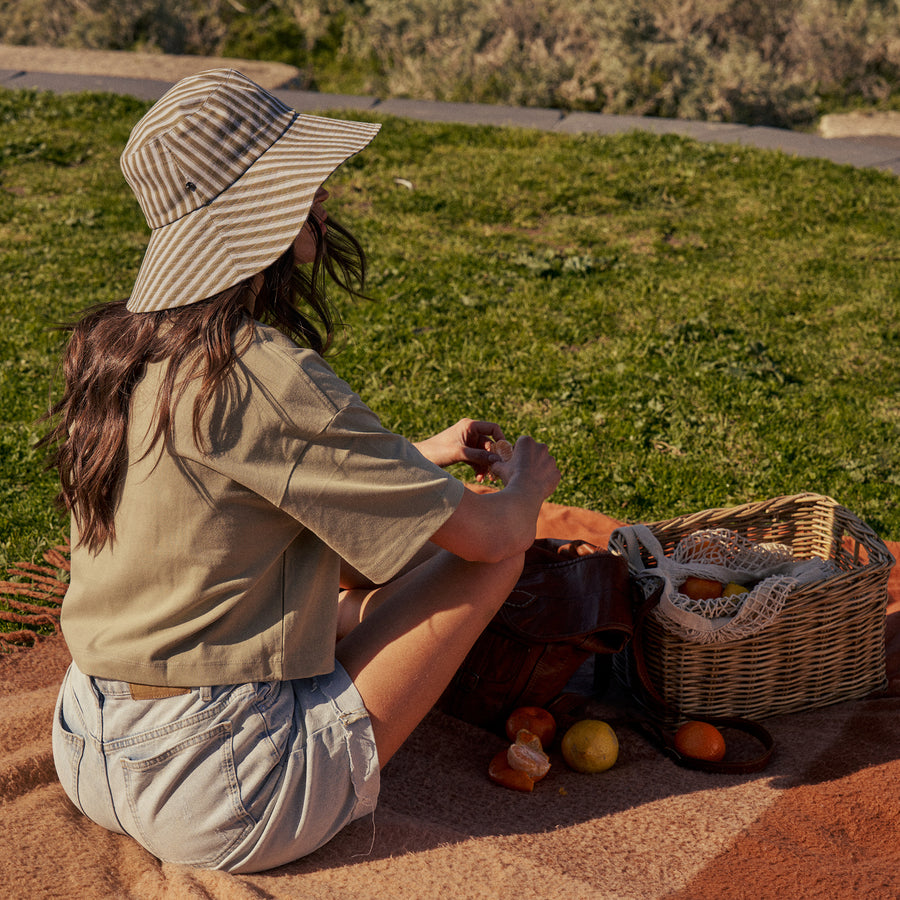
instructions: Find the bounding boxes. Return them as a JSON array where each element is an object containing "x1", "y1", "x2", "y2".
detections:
[{"x1": 336, "y1": 551, "x2": 524, "y2": 766}]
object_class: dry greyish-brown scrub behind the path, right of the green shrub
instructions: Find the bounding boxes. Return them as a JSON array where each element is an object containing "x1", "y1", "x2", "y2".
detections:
[{"x1": 345, "y1": 0, "x2": 900, "y2": 126}]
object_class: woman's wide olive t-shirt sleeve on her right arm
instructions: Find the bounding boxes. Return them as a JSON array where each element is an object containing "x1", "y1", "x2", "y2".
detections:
[{"x1": 181, "y1": 326, "x2": 465, "y2": 583}]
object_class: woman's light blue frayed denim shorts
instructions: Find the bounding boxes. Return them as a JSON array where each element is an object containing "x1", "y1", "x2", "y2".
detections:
[{"x1": 53, "y1": 662, "x2": 380, "y2": 872}]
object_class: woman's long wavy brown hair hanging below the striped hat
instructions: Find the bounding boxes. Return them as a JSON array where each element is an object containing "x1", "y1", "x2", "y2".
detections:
[{"x1": 38, "y1": 216, "x2": 366, "y2": 553}]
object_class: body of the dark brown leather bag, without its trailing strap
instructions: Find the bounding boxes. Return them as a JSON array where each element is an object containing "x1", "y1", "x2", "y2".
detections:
[{"x1": 438, "y1": 538, "x2": 633, "y2": 731}]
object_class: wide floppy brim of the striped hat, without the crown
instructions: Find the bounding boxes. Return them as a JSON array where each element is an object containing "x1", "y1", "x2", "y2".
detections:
[{"x1": 127, "y1": 115, "x2": 381, "y2": 312}]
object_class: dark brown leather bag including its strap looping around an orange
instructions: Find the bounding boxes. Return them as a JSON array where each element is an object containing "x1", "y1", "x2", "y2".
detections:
[{"x1": 438, "y1": 539, "x2": 774, "y2": 774}]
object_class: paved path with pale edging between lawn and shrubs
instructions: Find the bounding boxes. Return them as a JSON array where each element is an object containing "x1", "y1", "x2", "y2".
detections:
[{"x1": 0, "y1": 47, "x2": 900, "y2": 175}]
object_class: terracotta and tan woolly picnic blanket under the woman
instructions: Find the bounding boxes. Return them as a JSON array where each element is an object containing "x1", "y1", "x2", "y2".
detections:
[{"x1": 0, "y1": 504, "x2": 900, "y2": 900}]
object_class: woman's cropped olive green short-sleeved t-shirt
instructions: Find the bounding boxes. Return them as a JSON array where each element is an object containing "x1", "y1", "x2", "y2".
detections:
[{"x1": 62, "y1": 323, "x2": 464, "y2": 686}]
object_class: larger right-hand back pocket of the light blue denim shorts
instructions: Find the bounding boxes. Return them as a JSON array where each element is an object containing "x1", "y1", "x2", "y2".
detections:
[{"x1": 121, "y1": 721, "x2": 255, "y2": 868}]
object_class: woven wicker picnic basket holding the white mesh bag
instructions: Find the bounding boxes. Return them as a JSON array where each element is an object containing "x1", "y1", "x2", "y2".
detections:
[{"x1": 610, "y1": 494, "x2": 894, "y2": 718}]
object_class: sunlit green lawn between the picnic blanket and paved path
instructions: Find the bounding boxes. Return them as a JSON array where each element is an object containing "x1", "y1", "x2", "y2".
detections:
[{"x1": 0, "y1": 86, "x2": 900, "y2": 584}]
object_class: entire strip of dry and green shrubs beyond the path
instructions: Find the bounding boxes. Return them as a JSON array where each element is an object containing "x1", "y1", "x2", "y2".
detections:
[{"x1": 0, "y1": 0, "x2": 900, "y2": 127}]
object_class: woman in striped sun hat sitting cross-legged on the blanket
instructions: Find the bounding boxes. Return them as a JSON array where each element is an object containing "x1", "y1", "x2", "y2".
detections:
[{"x1": 46, "y1": 70, "x2": 559, "y2": 872}]
